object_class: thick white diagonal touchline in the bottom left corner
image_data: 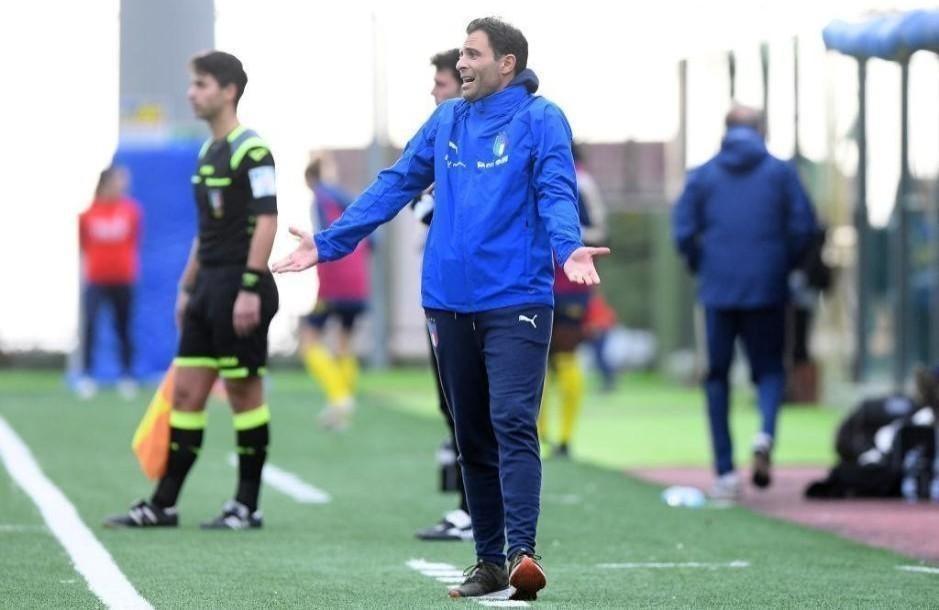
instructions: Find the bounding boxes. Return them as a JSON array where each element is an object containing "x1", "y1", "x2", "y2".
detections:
[{"x1": 0, "y1": 417, "x2": 153, "y2": 610}]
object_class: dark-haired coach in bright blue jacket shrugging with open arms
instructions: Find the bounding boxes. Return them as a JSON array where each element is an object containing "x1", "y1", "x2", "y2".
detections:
[{"x1": 273, "y1": 18, "x2": 609, "y2": 599}]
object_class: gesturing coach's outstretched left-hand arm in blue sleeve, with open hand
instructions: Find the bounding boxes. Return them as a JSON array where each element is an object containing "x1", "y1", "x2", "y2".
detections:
[{"x1": 271, "y1": 107, "x2": 440, "y2": 273}]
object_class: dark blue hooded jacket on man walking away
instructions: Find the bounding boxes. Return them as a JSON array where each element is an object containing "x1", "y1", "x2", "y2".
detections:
[{"x1": 672, "y1": 127, "x2": 815, "y2": 309}]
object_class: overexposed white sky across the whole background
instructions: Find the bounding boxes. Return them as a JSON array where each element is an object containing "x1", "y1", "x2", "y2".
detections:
[{"x1": 0, "y1": 0, "x2": 939, "y2": 350}]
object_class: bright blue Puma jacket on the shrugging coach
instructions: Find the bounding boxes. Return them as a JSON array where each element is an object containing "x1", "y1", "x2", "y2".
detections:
[{"x1": 314, "y1": 70, "x2": 583, "y2": 313}]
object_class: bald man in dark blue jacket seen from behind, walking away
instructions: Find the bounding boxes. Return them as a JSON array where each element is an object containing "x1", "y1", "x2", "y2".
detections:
[{"x1": 672, "y1": 106, "x2": 815, "y2": 498}]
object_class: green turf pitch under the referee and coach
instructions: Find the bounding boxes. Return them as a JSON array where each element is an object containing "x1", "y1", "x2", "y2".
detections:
[{"x1": 0, "y1": 370, "x2": 939, "y2": 609}]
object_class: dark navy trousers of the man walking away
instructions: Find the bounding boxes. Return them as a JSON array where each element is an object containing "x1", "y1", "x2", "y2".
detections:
[{"x1": 704, "y1": 305, "x2": 786, "y2": 475}]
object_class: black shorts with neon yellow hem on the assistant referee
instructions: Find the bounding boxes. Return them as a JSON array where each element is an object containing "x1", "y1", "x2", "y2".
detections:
[{"x1": 174, "y1": 266, "x2": 279, "y2": 379}]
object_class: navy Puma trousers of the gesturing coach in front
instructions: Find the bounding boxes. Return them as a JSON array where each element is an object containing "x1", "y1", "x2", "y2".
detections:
[{"x1": 426, "y1": 305, "x2": 552, "y2": 563}]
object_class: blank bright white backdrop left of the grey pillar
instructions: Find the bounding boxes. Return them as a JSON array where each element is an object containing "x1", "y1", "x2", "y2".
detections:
[{"x1": 0, "y1": 0, "x2": 119, "y2": 350}]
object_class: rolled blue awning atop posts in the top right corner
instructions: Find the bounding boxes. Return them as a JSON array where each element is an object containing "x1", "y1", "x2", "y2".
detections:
[{"x1": 822, "y1": 9, "x2": 939, "y2": 60}]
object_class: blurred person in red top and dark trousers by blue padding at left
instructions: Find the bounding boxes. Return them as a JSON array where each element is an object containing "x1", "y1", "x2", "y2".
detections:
[{"x1": 76, "y1": 166, "x2": 140, "y2": 399}]
